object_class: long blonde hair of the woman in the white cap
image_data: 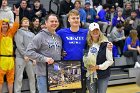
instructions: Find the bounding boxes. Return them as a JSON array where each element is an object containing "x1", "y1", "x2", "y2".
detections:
[{"x1": 87, "y1": 31, "x2": 108, "y2": 47}]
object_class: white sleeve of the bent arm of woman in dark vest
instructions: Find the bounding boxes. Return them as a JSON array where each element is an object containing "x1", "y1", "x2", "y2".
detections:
[{"x1": 99, "y1": 44, "x2": 114, "y2": 70}]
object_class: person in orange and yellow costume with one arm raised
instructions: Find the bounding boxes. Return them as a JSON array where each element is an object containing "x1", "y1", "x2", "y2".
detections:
[{"x1": 0, "y1": 8, "x2": 19, "y2": 93}]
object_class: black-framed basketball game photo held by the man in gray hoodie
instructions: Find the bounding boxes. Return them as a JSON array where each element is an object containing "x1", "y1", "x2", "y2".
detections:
[{"x1": 46, "y1": 60, "x2": 82, "y2": 91}]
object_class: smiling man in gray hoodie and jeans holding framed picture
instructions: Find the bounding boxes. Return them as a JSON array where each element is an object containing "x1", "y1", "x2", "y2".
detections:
[{"x1": 26, "y1": 14, "x2": 62, "y2": 93}]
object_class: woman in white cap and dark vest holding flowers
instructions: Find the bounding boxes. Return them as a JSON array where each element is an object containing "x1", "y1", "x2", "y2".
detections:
[{"x1": 83, "y1": 23, "x2": 114, "y2": 93}]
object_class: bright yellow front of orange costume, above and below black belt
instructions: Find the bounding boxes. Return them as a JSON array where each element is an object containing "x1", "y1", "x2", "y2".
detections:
[{"x1": 0, "y1": 37, "x2": 14, "y2": 70}]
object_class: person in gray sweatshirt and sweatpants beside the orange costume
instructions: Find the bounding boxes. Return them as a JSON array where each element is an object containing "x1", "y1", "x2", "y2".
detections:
[{"x1": 14, "y1": 17, "x2": 36, "y2": 93}]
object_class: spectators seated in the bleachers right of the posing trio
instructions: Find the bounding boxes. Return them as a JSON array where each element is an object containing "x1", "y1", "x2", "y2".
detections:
[{"x1": 59, "y1": 0, "x2": 140, "y2": 68}]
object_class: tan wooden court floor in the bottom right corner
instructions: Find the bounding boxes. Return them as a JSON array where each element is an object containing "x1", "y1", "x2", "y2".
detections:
[{"x1": 107, "y1": 84, "x2": 140, "y2": 93}]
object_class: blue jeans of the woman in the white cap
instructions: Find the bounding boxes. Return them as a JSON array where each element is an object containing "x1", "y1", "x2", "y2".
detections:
[{"x1": 87, "y1": 77, "x2": 109, "y2": 93}]
